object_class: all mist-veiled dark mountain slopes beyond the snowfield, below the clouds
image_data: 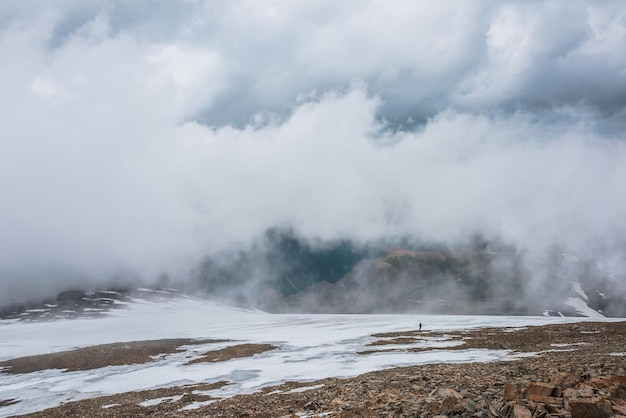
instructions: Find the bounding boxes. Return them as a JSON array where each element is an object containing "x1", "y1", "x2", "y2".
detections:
[{"x1": 0, "y1": 229, "x2": 626, "y2": 318}]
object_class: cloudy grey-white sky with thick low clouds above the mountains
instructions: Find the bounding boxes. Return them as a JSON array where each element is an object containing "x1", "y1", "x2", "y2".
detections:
[{"x1": 0, "y1": 0, "x2": 626, "y2": 303}]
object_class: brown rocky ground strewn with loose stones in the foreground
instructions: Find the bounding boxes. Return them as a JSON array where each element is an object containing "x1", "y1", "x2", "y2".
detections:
[{"x1": 0, "y1": 322, "x2": 626, "y2": 418}]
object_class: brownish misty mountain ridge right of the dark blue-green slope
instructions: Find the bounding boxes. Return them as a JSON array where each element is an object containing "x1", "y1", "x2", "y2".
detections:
[{"x1": 247, "y1": 237, "x2": 626, "y2": 317}]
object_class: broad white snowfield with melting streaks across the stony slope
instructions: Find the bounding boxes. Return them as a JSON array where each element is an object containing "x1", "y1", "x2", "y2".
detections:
[{"x1": 0, "y1": 298, "x2": 616, "y2": 417}]
